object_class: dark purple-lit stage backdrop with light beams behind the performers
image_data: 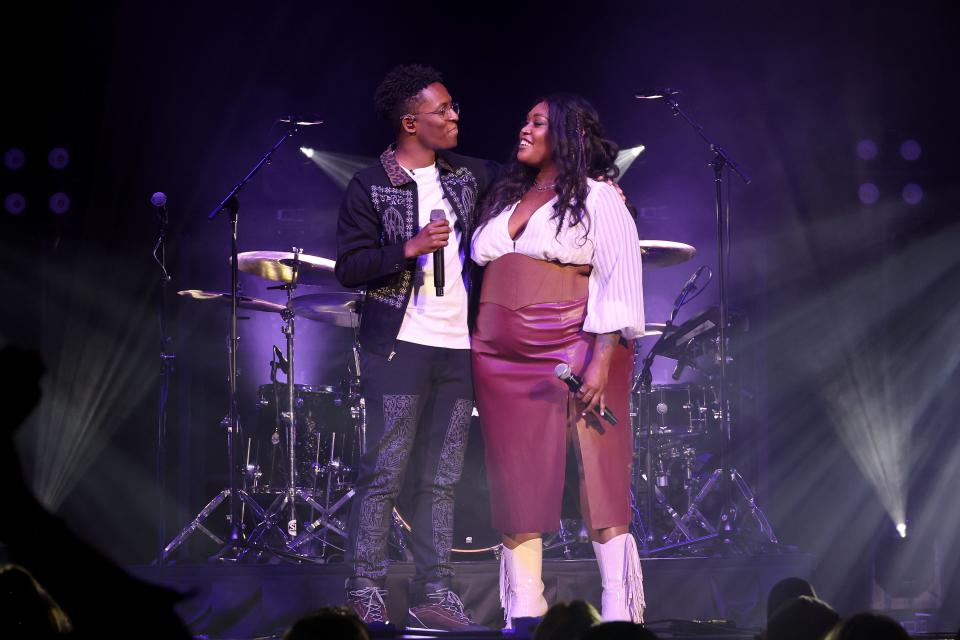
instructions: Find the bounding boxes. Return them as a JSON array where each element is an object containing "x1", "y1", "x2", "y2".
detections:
[{"x1": 0, "y1": 2, "x2": 960, "y2": 624}]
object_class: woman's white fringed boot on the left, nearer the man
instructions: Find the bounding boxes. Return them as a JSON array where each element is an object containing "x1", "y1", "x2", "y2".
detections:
[{"x1": 500, "y1": 538, "x2": 547, "y2": 629}]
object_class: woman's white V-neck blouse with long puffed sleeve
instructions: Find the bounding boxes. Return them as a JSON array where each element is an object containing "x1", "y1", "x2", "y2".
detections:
[{"x1": 471, "y1": 179, "x2": 644, "y2": 340}]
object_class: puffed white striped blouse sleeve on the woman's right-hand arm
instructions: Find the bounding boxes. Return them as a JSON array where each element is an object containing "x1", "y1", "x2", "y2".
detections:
[{"x1": 583, "y1": 182, "x2": 644, "y2": 340}]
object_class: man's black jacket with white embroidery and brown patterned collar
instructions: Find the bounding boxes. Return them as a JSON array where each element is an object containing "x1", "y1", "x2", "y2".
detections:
[{"x1": 335, "y1": 146, "x2": 497, "y2": 355}]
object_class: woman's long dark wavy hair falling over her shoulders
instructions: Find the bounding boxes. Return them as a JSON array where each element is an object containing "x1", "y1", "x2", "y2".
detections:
[{"x1": 480, "y1": 93, "x2": 620, "y2": 237}]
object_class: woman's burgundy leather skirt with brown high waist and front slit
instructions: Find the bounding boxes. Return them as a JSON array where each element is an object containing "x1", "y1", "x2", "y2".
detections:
[{"x1": 472, "y1": 253, "x2": 633, "y2": 534}]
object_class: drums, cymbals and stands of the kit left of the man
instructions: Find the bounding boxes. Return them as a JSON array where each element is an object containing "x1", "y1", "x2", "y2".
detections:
[{"x1": 162, "y1": 247, "x2": 366, "y2": 561}]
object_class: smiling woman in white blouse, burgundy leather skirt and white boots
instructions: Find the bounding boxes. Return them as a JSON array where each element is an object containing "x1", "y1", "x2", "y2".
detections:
[{"x1": 472, "y1": 94, "x2": 644, "y2": 625}]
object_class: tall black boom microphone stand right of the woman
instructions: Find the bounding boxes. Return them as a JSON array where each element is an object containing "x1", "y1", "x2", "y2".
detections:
[{"x1": 663, "y1": 92, "x2": 750, "y2": 531}]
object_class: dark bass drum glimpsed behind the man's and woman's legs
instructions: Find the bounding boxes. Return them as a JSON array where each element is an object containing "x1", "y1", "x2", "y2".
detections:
[{"x1": 392, "y1": 411, "x2": 500, "y2": 560}]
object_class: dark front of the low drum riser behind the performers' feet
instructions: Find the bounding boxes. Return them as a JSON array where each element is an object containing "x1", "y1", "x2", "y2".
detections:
[{"x1": 130, "y1": 553, "x2": 814, "y2": 638}]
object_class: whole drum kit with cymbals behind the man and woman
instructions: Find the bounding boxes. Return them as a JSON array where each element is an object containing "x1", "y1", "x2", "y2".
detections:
[{"x1": 162, "y1": 240, "x2": 773, "y2": 563}]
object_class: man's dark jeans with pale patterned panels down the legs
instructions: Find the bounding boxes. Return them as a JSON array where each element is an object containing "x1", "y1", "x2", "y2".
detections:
[{"x1": 346, "y1": 341, "x2": 473, "y2": 589}]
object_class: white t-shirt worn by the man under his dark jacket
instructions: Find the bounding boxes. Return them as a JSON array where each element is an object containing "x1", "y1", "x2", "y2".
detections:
[{"x1": 397, "y1": 164, "x2": 470, "y2": 349}]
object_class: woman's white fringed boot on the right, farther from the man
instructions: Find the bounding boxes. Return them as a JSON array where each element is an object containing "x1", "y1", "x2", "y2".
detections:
[{"x1": 593, "y1": 533, "x2": 647, "y2": 622}]
